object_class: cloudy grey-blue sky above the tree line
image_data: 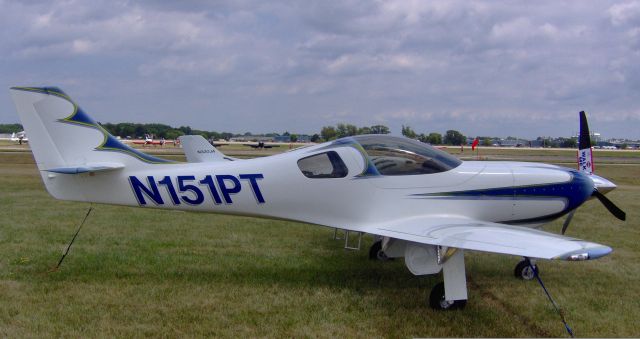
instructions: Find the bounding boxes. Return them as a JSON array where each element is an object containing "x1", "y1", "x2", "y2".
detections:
[{"x1": 0, "y1": 0, "x2": 640, "y2": 139}]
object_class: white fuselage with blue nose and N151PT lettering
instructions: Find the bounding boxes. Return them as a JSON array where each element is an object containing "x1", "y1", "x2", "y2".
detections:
[{"x1": 43, "y1": 145, "x2": 593, "y2": 234}]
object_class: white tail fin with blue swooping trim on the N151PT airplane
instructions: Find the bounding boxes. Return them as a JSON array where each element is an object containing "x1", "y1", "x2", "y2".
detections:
[{"x1": 11, "y1": 87, "x2": 170, "y2": 200}]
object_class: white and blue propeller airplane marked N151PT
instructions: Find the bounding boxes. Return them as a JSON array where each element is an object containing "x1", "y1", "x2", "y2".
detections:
[{"x1": 11, "y1": 87, "x2": 624, "y2": 309}]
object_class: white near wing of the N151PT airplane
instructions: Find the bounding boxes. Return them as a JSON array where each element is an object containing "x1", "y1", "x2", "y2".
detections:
[{"x1": 365, "y1": 216, "x2": 612, "y2": 260}]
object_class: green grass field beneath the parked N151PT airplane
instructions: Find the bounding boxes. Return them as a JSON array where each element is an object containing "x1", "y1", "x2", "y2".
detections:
[{"x1": 0, "y1": 150, "x2": 640, "y2": 338}]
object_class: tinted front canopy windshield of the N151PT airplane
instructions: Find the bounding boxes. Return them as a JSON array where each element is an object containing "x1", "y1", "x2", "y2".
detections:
[{"x1": 353, "y1": 135, "x2": 462, "y2": 175}]
